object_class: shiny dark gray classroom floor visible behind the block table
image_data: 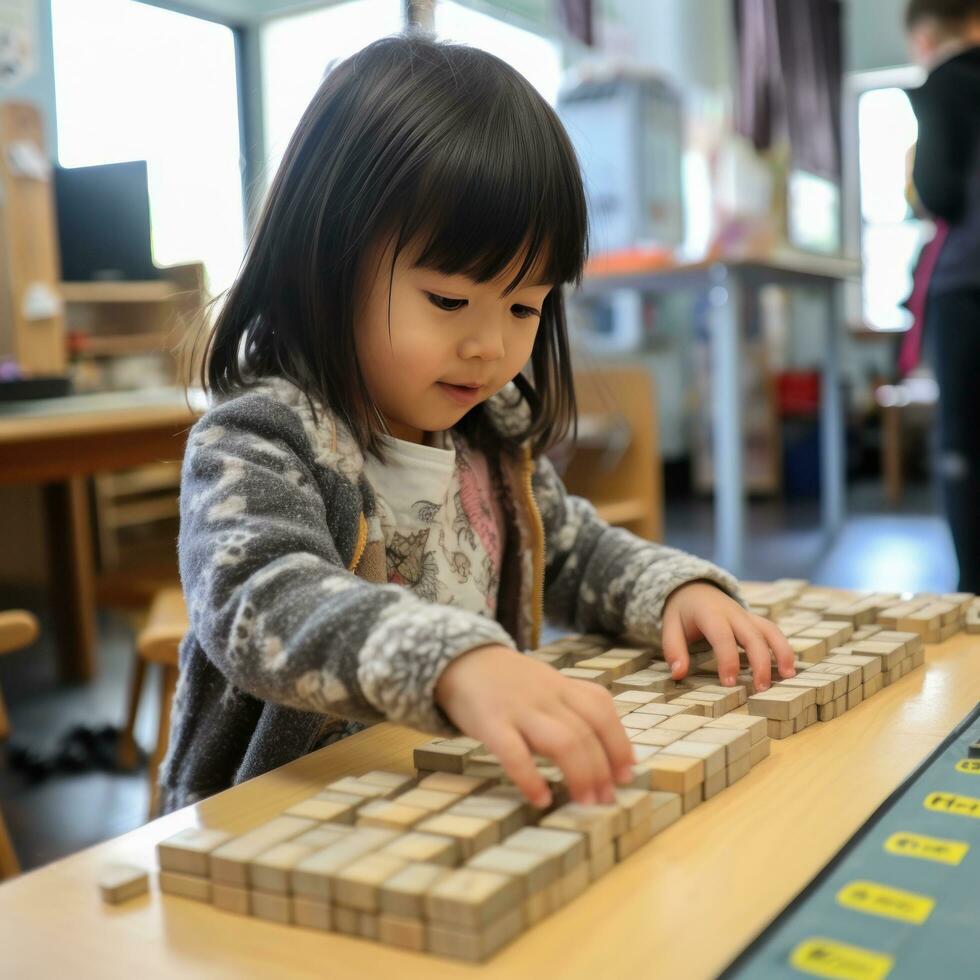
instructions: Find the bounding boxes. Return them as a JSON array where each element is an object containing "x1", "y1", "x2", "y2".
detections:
[{"x1": 0, "y1": 483, "x2": 956, "y2": 870}]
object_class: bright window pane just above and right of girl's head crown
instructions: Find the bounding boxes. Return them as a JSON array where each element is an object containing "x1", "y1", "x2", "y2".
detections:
[{"x1": 435, "y1": 0, "x2": 561, "y2": 106}]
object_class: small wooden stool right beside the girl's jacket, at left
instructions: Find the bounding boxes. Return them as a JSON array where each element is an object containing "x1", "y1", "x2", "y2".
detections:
[{"x1": 119, "y1": 588, "x2": 188, "y2": 819}]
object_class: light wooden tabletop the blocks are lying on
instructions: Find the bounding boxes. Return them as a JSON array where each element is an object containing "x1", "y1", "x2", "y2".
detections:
[{"x1": 0, "y1": 634, "x2": 980, "y2": 980}]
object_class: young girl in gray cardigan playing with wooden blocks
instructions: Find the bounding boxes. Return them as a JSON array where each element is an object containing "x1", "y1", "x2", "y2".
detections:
[{"x1": 161, "y1": 36, "x2": 793, "y2": 811}]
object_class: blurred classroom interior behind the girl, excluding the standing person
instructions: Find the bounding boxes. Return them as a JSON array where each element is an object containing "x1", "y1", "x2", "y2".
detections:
[{"x1": 0, "y1": 0, "x2": 957, "y2": 869}]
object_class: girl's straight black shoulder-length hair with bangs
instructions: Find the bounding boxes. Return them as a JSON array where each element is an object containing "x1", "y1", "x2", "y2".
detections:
[{"x1": 195, "y1": 34, "x2": 588, "y2": 455}]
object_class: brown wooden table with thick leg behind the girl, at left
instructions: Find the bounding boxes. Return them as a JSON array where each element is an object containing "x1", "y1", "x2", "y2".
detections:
[{"x1": 0, "y1": 388, "x2": 197, "y2": 680}]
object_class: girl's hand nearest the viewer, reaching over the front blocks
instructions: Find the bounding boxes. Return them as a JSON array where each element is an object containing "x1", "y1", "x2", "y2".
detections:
[{"x1": 435, "y1": 645, "x2": 635, "y2": 807}]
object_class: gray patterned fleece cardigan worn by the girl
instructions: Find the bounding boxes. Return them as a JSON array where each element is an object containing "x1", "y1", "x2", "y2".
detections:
[{"x1": 161, "y1": 379, "x2": 737, "y2": 812}]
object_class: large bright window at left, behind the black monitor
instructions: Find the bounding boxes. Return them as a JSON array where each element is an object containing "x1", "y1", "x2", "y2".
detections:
[{"x1": 51, "y1": 0, "x2": 244, "y2": 293}]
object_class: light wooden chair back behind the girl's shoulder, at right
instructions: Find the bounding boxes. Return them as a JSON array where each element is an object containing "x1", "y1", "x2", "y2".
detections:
[{"x1": 562, "y1": 365, "x2": 663, "y2": 541}]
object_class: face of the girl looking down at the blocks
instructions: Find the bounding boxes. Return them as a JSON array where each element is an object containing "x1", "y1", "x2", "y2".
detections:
[{"x1": 354, "y1": 237, "x2": 552, "y2": 442}]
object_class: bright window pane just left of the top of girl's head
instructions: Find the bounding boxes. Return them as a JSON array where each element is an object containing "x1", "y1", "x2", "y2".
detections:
[{"x1": 261, "y1": 0, "x2": 403, "y2": 184}]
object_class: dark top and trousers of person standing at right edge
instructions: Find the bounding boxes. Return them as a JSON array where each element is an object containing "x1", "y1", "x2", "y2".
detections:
[{"x1": 908, "y1": 47, "x2": 980, "y2": 593}]
